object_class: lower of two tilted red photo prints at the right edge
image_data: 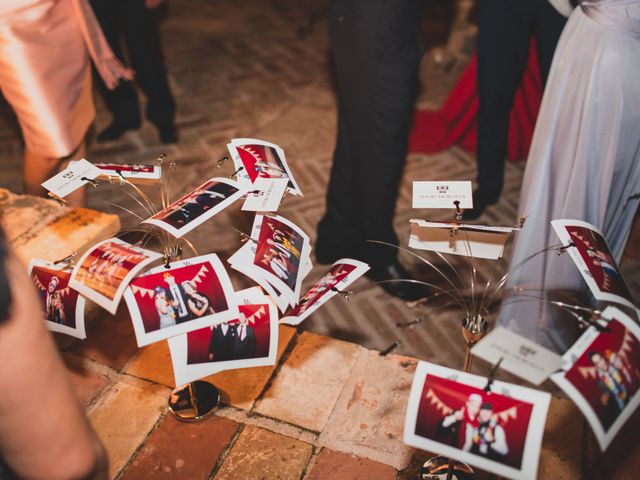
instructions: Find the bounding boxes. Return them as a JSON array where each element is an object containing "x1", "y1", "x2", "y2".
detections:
[{"x1": 551, "y1": 307, "x2": 640, "y2": 451}]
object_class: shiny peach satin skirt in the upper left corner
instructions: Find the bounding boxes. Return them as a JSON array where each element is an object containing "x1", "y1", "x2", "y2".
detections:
[{"x1": 0, "y1": 0, "x2": 95, "y2": 157}]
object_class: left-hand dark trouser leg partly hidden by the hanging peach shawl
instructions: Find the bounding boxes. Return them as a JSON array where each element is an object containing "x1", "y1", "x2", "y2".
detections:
[{"x1": 91, "y1": 0, "x2": 140, "y2": 126}]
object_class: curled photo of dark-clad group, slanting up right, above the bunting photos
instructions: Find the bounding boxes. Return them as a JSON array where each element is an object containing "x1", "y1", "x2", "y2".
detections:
[{"x1": 142, "y1": 178, "x2": 246, "y2": 238}]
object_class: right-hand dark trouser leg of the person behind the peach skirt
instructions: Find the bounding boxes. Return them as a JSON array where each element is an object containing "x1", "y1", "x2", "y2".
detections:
[{"x1": 120, "y1": 0, "x2": 175, "y2": 127}]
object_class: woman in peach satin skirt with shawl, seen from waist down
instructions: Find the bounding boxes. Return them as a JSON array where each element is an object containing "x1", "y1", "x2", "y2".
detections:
[{"x1": 0, "y1": 0, "x2": 132, "y2": 206}]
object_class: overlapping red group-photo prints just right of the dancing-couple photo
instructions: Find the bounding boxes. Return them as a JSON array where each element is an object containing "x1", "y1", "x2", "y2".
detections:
[{"x1": 229, "y1": 215, "x2": 311, "y2": 305}]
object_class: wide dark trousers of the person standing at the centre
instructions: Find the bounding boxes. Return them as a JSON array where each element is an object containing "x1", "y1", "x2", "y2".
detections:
[{"x1": 319, "y1": 0, "x2": 422, "y2": 265}]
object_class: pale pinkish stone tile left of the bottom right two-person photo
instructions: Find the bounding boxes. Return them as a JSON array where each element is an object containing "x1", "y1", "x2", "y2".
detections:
[{"x1": 319, "y1": 350, "x2": 416, "y2": 470}]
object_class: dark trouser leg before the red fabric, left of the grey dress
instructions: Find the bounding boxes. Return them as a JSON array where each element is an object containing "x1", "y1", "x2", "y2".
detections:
[{"x1": 477, "y1": 0, "x2": 537, "y2": 202}]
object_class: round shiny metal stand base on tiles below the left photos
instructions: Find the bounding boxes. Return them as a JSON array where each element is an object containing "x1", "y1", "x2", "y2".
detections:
[{"x1": 169, "y1": 380, "x2": 220, "y2": 422}]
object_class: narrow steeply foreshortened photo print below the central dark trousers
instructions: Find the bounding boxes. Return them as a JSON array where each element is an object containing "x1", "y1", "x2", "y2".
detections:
[{"x1": 280, "y1": 258, "x2": 369, "y2": 325}]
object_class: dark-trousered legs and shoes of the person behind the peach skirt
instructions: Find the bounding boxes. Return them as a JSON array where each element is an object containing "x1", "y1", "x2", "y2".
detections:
[{"x1": 90, "y1": 0, "x2": 178, "y2": 144}]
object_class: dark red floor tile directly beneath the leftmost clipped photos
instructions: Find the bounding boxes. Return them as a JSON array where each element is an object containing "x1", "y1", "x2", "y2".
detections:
[{"x1": 69, "y1": 302, "x2": 138, "y2": 371}]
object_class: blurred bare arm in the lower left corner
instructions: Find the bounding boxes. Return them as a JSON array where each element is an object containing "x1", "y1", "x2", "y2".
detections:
[{"x1": 0, "y1": 249, "x2": 107, "y2": 480}]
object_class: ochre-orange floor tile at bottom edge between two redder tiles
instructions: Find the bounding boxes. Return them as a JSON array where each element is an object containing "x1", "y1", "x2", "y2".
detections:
[{"x1": 214, "y1": 425, "x2": 313, "y2": 480}]
